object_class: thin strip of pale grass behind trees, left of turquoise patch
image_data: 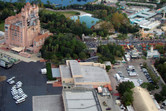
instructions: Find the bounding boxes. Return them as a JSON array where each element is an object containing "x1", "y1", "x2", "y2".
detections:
[{"x1": 45, "y1": 10, "x2": 80, "y2": 18}]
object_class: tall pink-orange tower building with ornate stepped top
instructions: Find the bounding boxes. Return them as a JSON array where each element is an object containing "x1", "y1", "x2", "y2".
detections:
[{"x1": 5, "y1": 3, "x2": 49, "y2": 53}]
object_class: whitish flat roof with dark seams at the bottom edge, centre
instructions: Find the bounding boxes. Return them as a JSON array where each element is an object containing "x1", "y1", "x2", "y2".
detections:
[{"x1": 63, "y1": 91, "x2": 101, "y2": 111}]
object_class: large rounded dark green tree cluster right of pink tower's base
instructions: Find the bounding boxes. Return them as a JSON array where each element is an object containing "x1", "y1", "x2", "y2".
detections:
[{"x1": 41, "y1": 33, "x2": 89, "y2": 64}]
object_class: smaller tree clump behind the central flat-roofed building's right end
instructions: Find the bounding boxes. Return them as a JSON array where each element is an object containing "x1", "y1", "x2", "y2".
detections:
[{"x1": 97, "y1": 44, "x2": 124, "y2": 64}]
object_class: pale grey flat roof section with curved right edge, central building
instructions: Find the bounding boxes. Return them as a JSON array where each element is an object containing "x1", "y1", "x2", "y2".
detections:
[{"x1": 74, "y1": 66, "x2": 110, "y2": 83}]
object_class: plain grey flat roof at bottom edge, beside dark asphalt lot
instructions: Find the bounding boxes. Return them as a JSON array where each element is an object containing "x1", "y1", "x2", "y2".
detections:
[{"x1": 33, "y1": 95, "x2": 64, "y2": 111}]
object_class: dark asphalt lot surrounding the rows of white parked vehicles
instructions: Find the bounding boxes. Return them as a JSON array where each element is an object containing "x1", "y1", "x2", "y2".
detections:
[{"x1": 0, "y1": 62, "x2": 62, "y2": 111}]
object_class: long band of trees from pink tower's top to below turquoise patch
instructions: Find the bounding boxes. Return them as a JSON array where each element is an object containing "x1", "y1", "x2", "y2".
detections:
[{"x1": 39, "y1": 10, "x2": 113, "y2": 37}]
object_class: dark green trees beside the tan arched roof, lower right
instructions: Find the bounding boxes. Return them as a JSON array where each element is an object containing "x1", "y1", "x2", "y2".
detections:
[{"x1": 116, "y1": 81, "x2": 134, "y2": 106}]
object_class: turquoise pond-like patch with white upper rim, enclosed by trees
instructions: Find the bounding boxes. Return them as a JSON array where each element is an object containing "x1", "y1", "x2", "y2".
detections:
[{"x1": 71, "y1": 14, "x2": 100, "y2": 28}]
